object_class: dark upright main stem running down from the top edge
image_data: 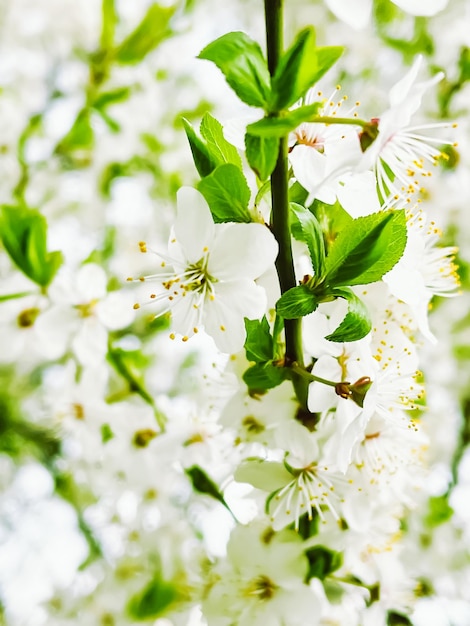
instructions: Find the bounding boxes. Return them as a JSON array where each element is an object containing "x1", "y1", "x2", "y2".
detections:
[{"x1": 264, "y1": 0, "x2": 309, "y2": 409}]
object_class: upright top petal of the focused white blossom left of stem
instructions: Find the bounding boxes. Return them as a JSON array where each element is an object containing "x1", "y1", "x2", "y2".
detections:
[{"x1": 175, "y1": 187, "x2": 215, "y2": 263}]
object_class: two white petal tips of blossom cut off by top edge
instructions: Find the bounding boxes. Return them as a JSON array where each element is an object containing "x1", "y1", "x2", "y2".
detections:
[{"x1": 325, "y1": 0, "x2": 448, "y2": 29}]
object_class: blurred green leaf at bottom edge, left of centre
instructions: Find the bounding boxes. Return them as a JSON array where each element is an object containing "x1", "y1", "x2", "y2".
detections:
[{"x1": 127, "y1": 574, "x2": 180, "y2": 622}]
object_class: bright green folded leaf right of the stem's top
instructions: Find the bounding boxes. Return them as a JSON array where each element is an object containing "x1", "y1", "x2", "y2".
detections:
[{"x1": 270, "y1": 27, "x2": 343, "y2": 111}]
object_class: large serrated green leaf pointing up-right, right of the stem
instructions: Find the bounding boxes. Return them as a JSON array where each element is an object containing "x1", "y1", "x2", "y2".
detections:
[{"x1": 325, "y1": 209, "x2": 407, "y2": 286}]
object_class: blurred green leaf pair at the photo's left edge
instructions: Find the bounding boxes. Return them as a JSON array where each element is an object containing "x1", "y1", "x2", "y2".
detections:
[{"x1": 0, "y1": 206, "x2": 63, "y2": 287}]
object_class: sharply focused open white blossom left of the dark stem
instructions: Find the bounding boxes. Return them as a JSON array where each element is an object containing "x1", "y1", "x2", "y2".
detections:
[{"x1": 135, "y1": 187, "x2": 278, "y2": 352}]
